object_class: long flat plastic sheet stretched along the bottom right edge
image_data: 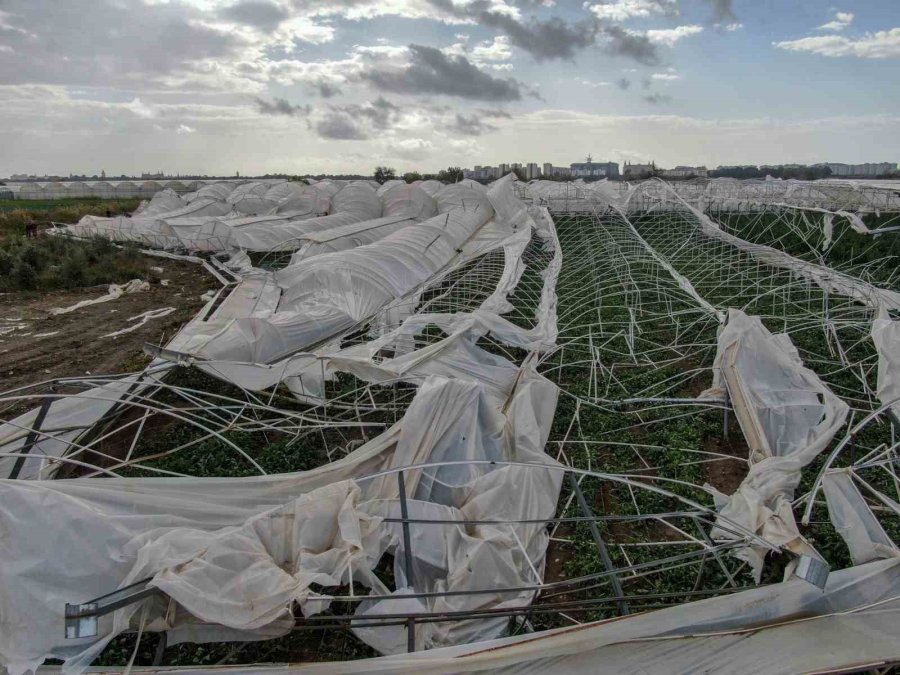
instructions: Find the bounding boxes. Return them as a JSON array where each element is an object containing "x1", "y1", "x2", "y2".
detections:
[{"x1": 41, "y1": 560, "x2": 900, "y2": 675}]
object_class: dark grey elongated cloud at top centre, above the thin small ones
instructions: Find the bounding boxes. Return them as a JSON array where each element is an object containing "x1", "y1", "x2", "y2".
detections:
[{"x1": 360, "y1": 44, "x2": 522, "y2": 101}]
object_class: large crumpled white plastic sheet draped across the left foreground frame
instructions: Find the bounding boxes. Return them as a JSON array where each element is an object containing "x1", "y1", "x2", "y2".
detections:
[{"x1": 0, "y1": 369, "x2": 562, "y2": 673}]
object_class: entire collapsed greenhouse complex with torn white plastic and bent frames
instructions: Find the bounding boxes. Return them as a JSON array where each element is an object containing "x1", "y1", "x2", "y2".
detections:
[{"x1": 0, "y1": 176, "x2": 900, "y2": 674}]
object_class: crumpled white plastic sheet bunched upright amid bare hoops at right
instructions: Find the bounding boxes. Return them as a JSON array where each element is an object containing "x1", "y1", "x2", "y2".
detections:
[{"x1": 711, "y1": 309, "x2": 849, "y2": 581}]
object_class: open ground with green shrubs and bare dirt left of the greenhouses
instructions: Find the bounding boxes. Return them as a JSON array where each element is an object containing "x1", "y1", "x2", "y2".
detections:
[{"x1": 0, "y1": 200, "x2": 218, "y2": 402}]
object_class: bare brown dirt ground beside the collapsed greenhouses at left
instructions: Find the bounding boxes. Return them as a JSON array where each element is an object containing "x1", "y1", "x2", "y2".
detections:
[{"x1": 0, "y1": 258, "x2": 219, "y2": 391}]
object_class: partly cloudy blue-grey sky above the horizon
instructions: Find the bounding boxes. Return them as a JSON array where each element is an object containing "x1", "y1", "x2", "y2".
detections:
[{"x1": 0, "y1": 0, "x2": 900, "y2": 176}]
